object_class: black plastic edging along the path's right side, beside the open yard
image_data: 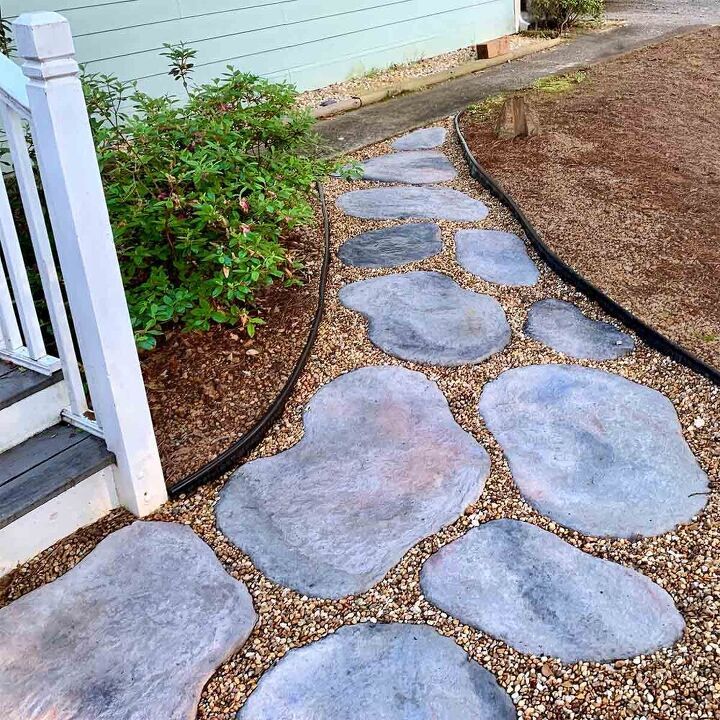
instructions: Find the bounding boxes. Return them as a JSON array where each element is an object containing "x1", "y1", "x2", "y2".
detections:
[{"x1": 454, "y1": 113, "x2": 720, "y2": 385}]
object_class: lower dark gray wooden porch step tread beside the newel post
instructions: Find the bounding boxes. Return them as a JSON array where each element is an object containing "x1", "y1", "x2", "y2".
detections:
[{"x1": 0, "y1": 424, "x2": 115, "y2": 528}]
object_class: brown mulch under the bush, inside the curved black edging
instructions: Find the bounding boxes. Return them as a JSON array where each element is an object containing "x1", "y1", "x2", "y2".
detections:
[{"x1": 141, "y1": 206, "x2": 323, "y2": 486}]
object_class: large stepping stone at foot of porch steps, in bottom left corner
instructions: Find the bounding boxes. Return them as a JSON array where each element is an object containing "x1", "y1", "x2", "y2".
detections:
[{"x1": 0, "y1": 522, "x2": 257, "y2": 720}]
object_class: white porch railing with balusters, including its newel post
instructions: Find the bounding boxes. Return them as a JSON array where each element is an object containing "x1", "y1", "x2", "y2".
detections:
[{"x1": 0, "y1": 12, "x2": 167, "y2": 516}]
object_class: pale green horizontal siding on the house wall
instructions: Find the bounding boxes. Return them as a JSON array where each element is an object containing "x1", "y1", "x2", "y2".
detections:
[{"x1": 0, "y1": 0, "x2": 515, "y2": 93}]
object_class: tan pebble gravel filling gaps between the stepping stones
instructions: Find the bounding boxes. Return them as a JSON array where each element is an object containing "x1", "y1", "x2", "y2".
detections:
[{"x1": 0, "y1": 121, "x2": 720, "y2": 720}]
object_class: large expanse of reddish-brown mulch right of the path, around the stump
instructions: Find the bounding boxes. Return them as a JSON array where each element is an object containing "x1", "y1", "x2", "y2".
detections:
[{"x1": 463, "y1": 28, "x2": 720, "y2": 368}]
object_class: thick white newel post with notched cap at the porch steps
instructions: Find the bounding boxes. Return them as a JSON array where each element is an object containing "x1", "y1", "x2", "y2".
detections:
[{"x1": 13, "y1": 12, "x2": 167, "y2": 516}]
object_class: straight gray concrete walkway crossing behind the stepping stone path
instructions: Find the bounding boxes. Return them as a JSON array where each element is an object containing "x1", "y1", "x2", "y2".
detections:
[{"x1": 319, "y1": 0, "x2": 720, "y2": 153}]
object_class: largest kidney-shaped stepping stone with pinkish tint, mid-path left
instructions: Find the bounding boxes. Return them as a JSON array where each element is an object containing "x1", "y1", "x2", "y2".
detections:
[{"x1": 216, "y1": 367, "x2": 490, "y2": 598}]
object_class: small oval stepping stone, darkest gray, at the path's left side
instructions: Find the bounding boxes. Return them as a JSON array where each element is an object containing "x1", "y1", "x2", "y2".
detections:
[{"x1": 338, "y1": 223, "x2": 442, "y2": 268}]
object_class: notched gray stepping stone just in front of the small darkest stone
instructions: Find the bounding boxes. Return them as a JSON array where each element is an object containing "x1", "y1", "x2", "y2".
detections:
[{"x1": 340, "y1": 272, "x2": 510, "y2": 366}]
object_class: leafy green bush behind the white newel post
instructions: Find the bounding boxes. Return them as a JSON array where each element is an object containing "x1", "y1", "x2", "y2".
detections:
[{"x1": 84, "y1": 54, "x2": 333, "y2": 348}]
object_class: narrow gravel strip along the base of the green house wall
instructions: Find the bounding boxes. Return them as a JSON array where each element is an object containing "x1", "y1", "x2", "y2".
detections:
[{"x1": 297, "y1": 35, "x2": 556, "y2": 109}]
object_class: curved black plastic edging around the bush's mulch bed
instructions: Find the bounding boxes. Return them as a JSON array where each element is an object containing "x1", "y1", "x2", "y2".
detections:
[{"x1": 168, "y1": 183, "x2": 330, "y2": 498}]
